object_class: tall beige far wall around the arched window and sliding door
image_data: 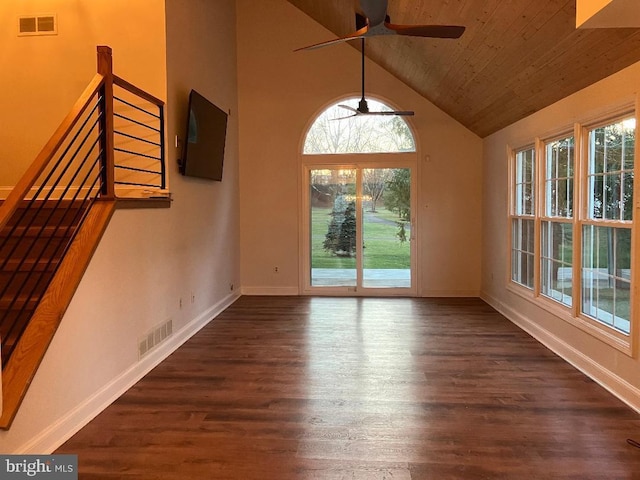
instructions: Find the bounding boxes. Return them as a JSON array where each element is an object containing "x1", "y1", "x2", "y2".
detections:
[{"x1": 237, "y1": 0, "x2": 482, "y2": 295}]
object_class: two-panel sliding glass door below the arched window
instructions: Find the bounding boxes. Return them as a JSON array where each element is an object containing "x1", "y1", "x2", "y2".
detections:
[{"x1": 303, "y1": 164, "x2": 416, "y2": 295}]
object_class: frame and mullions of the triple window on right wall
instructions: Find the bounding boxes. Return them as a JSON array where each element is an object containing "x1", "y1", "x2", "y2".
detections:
[{"x1": 506, "y1": 108, "x2": 640, "y2": 357}]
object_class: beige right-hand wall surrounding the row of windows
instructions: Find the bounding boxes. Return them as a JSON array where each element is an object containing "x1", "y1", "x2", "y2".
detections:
[{"x1": 482, "y1": 63, "x2": 640, "y2": 409}]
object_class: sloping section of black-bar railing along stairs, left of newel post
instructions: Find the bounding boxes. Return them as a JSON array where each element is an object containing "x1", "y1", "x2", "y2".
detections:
[{"x1": 0, "y1": 82, "x2": 105, "y2": 364}]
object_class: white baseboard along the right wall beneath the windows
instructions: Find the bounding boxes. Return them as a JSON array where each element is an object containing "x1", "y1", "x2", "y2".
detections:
[{"x1": 480, "y1": 294, "x2": 640, "y2": 413}]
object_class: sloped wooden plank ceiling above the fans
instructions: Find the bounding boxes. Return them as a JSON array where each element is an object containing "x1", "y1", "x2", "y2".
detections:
[{"x1": 288, "y1": 0, "x2": 640, "y2": 137}]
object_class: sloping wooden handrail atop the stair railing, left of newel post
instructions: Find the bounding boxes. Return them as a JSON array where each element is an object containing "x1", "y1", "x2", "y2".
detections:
[{"x1": 0, "y1": 74, "x2": 104, "y2": 233}]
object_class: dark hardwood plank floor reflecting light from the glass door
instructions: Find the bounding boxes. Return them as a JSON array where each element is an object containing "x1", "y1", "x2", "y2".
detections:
[{"x1": 56, "y1": 297, "x2": 640, "y2": 480}]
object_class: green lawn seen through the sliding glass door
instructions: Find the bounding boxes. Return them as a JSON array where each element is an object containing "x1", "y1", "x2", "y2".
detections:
[{"x1": 311, "y1": 207, "x2": 410, "y2": 269}]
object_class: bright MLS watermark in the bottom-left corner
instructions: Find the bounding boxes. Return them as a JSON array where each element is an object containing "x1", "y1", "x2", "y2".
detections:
[{"x1": 0, "y1": 455, "x2": 78, "y2": 480}]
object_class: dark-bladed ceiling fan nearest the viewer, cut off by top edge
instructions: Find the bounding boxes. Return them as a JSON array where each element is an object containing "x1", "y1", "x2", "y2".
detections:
[{"x1": 295, "y1": 0, "x2": 465, "y2": 51}]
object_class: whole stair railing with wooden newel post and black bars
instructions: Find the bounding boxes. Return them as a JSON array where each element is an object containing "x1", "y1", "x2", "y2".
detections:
[{"x1": 0, "y1": 46, "x2": 166, "y2": 365}]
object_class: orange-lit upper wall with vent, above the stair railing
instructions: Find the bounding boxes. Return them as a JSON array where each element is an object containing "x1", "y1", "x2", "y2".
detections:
[{"x1": 0, "y1": 0, "x2": 166, "y2": 191}]
